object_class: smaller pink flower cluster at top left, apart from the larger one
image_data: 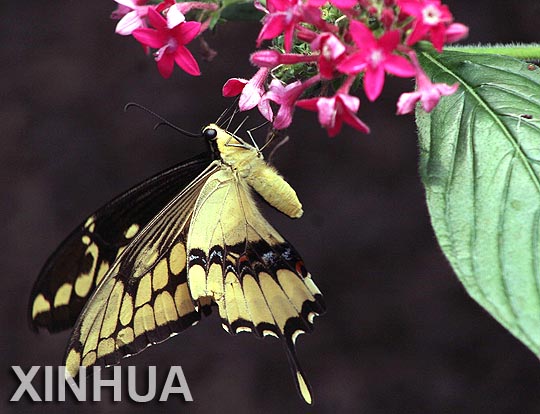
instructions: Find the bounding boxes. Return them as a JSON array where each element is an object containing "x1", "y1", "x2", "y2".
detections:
[{"x1": 111, "y1": 0, "x2": 218, "y2": 78}]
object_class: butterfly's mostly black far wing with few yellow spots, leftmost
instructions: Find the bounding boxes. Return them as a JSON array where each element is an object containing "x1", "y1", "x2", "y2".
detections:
[{"x1": 28, "y1": 153, "x2": 211, "y2": 332}]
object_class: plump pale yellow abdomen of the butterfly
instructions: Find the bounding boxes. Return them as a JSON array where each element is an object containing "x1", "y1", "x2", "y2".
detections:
[{"x1": 246, "y1": 160, "x2": 304, "y2": 218}]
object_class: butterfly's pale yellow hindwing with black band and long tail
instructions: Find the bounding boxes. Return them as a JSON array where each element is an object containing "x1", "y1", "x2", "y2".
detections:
[{"x1": 187, "y1": 168, "x2": 325, "y2": 404}]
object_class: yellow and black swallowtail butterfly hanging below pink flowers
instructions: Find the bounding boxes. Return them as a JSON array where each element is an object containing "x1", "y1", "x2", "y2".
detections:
[{"x1": 29, "y1": 111, "x2": 325, "y2": 404}]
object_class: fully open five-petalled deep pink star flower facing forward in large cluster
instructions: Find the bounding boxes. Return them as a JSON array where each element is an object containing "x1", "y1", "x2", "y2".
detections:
[{"x1": 337, "y1": 20, "x2": 415, "y2": 101}]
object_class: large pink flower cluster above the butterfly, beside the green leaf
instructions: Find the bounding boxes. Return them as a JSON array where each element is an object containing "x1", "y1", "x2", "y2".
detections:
[{"x1": 221, "y1": 0, "x2": 468, "y2": 136}]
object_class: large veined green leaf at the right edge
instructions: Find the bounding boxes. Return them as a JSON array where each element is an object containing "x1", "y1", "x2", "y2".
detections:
[{"x1": 417, "y1": 47, "x2": 540, "y2": 356}]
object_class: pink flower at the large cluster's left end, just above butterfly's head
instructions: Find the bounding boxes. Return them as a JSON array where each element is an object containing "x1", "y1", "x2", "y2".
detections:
[{"x1": 222, "y1": 68, "x2": 273, "y2": 121}]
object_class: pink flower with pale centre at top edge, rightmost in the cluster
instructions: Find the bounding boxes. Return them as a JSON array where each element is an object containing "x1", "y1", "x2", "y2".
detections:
[{"x1": 398, "y1": 0, "x2": 453, "y2": 52}]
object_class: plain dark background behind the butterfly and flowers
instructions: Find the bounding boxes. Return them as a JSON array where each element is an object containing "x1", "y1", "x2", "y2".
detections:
[{"x1": 0, "y1": 0, "x2": 540, "y2": 413}]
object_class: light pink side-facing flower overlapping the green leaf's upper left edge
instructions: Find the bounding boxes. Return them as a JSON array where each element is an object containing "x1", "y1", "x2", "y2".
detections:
[{"x1": 397, "y1": 53, "x2": 459, "y2": 115}]
